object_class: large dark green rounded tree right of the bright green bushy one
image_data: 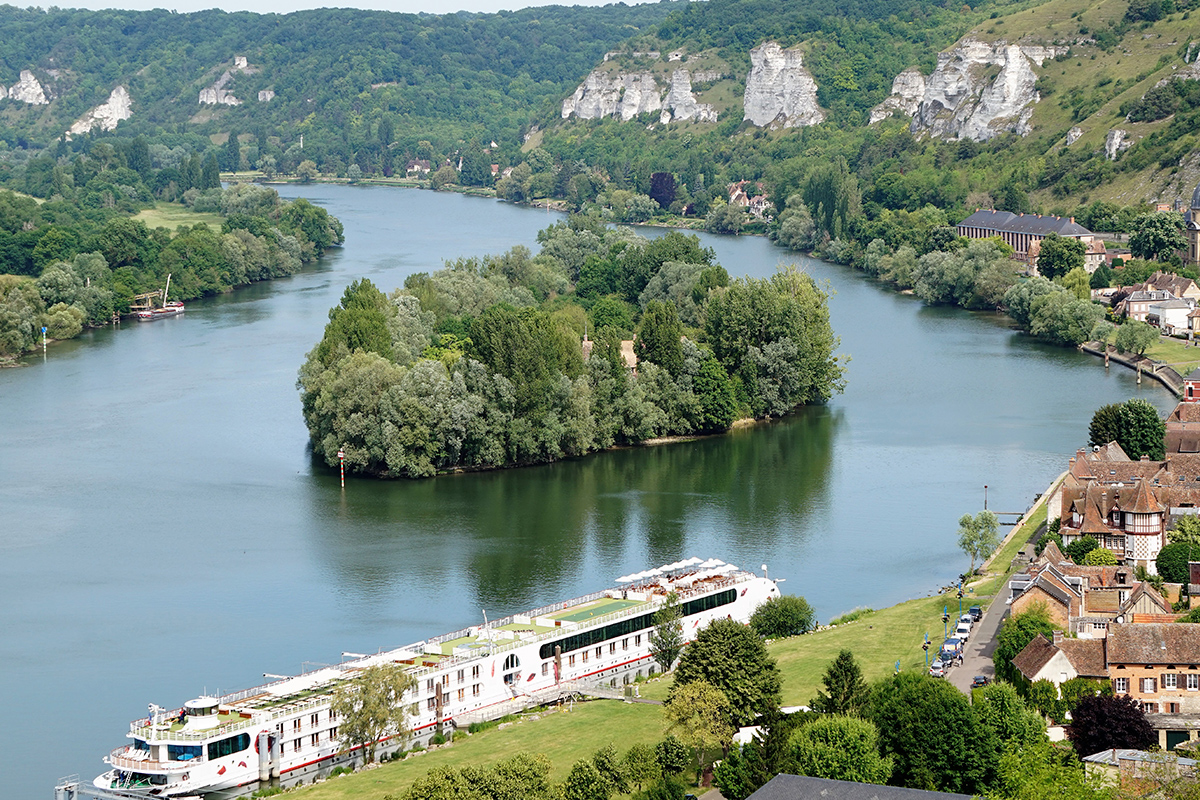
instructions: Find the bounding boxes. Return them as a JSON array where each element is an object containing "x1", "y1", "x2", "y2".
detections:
[{"x1": 868, "y1": 673, "x2": 996, "y2": 794}]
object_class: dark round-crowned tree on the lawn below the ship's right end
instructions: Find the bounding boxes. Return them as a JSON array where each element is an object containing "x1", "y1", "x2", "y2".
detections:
[{"x1": 671, "y1": 619, "x2": 780, "y2": 727}]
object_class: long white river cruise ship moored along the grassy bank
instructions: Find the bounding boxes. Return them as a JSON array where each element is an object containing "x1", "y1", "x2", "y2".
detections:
[{"x1": 94, "y1": 558, "x2": 780, "y2": 798}]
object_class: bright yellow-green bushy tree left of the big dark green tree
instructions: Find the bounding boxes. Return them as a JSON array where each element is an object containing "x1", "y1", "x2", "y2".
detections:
[{"x1": 791, "y1": 716, "x2": 894, "y2": 783}]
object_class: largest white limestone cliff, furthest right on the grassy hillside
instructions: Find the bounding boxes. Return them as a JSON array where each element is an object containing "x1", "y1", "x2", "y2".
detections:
[{"x1": 871, "y1": 37, "x2": 1066, "y2": 142}]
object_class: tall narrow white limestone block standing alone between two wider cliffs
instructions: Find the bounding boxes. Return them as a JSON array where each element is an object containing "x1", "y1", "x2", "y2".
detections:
[{"x1": 743, "y1": 42, "x2": 824, "y2": 128}]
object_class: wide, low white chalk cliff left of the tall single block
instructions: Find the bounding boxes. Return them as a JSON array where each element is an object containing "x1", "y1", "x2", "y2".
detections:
[{"x1": 562, "y1": 67, "x2": 719, "y2": 124}]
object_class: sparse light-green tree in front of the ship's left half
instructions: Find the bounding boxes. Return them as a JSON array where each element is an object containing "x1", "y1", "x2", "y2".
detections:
[{"x1": 330, "y1": 664, "x2": 416, "y2": 764}]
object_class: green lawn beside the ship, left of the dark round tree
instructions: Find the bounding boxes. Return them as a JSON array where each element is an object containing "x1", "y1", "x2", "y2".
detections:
[{"x1": 291, "y1": 700, "x2": 664, "y2": 800}]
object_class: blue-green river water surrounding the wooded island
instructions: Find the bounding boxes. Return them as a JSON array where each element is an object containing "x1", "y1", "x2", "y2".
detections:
[{"x1": 0, "y1": 186, "x2": 1174, "y2": 800}]
